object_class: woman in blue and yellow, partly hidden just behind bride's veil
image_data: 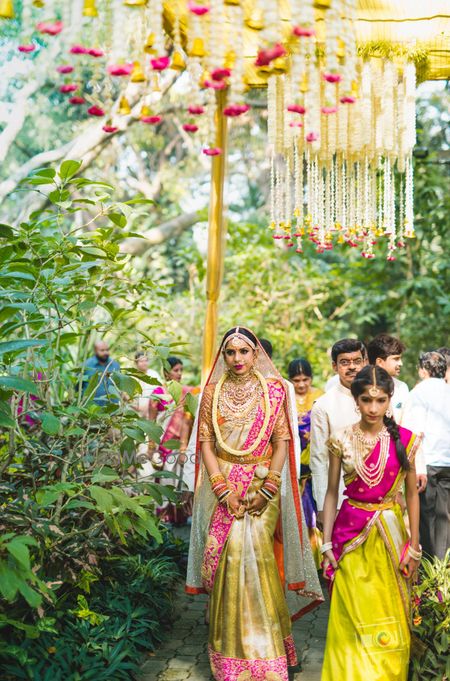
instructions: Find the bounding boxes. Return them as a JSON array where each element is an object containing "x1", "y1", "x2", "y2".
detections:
[{"x1": 288, "y1": 358, "x2": 323, "y2": 568}]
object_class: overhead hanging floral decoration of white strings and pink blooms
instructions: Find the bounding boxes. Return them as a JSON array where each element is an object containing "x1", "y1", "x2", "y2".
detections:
[{"x1": 0, "y1": 0, "x2": 422, "y2": 260}]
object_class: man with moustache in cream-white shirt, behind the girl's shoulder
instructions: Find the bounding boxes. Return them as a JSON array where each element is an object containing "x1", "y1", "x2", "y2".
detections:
[{"x1": 310, "y1": 338, "x2": 366, "y2": 524}]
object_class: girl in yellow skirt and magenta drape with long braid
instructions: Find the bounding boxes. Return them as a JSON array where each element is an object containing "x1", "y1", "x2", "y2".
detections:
[{"x1": 321, "y1": 366, "x2": 422, "y2": 681}]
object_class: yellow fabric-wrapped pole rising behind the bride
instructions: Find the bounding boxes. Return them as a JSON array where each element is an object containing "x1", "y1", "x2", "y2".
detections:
[{"x1": 202, "y1": 90, "x2": 228, "y2": 384}]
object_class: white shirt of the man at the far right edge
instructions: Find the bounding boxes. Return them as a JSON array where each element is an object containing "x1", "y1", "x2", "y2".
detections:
[{"x1": 402, "y1": 378, "x2": 450, "y2": 472}]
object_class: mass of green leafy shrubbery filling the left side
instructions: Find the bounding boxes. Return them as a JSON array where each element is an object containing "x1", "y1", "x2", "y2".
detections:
[{"x1": 0, "y1": 161, "x2": 190, "y2": 681}]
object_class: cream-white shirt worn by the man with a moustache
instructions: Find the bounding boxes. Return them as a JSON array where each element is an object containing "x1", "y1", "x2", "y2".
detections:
[{"x1": 310, "y1": 382, "x2": 360, "y2": 511}]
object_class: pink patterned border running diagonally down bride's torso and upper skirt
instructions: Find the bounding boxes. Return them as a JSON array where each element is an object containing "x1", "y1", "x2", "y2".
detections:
[{"x1": 202, "y1": 381, "x2": 285, "y2": 592}]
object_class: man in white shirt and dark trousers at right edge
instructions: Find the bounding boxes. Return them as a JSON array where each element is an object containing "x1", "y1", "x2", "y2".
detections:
[{"x1": 402, "y1": 352, "x2": 450, "y2": 558}]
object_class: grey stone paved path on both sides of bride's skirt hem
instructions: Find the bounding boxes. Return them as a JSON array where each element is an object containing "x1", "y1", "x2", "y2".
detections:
[{"x1": 139, "y1": 587, "x2": 328, "y2": 681}]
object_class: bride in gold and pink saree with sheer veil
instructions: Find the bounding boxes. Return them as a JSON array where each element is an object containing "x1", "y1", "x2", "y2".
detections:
[{"x1": 186, "y1": 327, "x2": 322, "y2": 681}]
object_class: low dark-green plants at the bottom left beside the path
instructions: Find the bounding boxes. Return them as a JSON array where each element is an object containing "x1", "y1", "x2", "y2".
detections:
[{"x1": 0, "y1": 530, "x2": 186, "y2": 681}]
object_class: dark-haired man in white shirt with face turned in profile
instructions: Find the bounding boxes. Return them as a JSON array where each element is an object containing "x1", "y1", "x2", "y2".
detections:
[{"x1": 367, "y1": 333, "x2": 427, "y2": 493}]
